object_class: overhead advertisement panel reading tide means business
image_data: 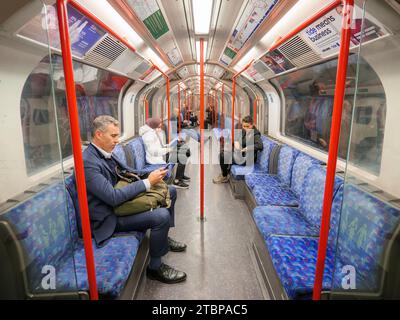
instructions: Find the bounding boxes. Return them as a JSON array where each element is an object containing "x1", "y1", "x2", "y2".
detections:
[{"x1": 300, "y1": 5, "x2": 389, "y2": 58}]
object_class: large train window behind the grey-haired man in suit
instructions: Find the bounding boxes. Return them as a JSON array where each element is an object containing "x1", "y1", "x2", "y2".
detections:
[{"x1": 20, "y1": 55, "x2": 129, "y2": 175}]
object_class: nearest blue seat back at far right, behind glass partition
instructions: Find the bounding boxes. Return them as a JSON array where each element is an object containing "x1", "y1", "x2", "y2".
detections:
[{"x1": 334, "y1": 184, "x2": 400, "y2": 293}]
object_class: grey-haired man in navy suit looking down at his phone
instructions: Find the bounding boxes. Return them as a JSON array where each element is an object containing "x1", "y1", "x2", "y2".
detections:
[{"x1": 83, "y1": 116, "x2": 186, "y2": 283}]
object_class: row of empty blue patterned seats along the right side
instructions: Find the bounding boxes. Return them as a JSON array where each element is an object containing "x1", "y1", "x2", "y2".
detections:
[{"x1": 232, "y1": 137, "x2": 400, "y2": 299}]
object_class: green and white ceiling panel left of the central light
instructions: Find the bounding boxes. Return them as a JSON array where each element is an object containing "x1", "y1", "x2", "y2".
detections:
[{"x1": 127, "y1": 0, "x2": 169, "y2": 40}]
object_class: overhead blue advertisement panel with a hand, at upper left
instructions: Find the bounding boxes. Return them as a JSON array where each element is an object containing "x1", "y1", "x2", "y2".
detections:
[{"x1": 18, "y1": 5, "x2": 106, "y2": 58}]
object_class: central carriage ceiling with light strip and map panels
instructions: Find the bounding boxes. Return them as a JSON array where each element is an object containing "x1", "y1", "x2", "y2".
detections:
[{"x1": 107, "y1": 0, "x2": 298, "y2": 93}]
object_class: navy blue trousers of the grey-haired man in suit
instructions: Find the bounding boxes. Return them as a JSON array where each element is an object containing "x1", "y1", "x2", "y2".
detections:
[{"x1": 115, "y1": 186, "x2": 176, "y2": 257}]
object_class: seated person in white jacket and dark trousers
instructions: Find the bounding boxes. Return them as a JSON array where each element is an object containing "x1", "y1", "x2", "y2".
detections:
[{"x1": 139, "y1": 118, "x2": 190, "y2": 189}]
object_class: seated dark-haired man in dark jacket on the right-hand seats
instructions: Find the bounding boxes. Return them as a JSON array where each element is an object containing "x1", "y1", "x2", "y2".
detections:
[{"x1": 213, "y1": 116, "x2": 263, "y2": 183}]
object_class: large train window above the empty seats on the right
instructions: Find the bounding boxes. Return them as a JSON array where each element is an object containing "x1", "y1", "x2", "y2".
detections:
[{"x1": 277, "y1": 55, "x2": 386, "y2": 175}]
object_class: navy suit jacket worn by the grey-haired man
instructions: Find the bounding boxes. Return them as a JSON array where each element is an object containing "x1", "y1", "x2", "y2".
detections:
[{"x1": 83, "y1": 144, "x2": 146, "y2": 246}]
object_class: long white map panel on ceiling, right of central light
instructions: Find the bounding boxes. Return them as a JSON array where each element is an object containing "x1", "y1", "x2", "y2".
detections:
[{"x1": 221, "y1": 0, "x2": 278, "y2": 65}]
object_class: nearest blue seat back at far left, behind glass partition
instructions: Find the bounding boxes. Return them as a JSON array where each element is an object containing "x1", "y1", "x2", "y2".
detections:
[{"x1": 2, "y1": 182, "x2": 78, "y2": 293}]
